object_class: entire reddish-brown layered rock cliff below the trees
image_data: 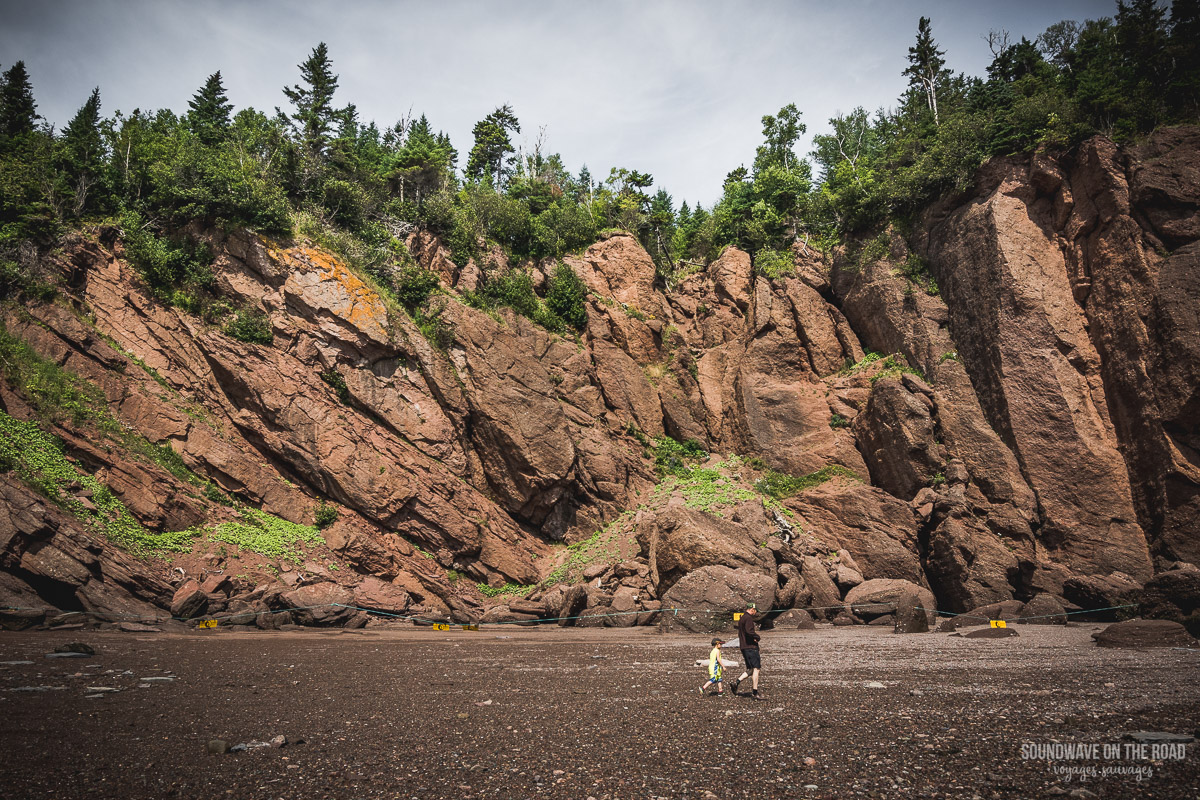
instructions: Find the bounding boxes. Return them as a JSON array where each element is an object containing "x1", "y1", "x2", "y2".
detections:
[{"x1": 0, "y1": 127, "x2": 1200, "y2": 627}]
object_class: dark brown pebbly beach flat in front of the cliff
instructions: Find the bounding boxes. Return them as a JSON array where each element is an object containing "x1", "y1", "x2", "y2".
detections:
[{"x1": 0, "y1": 625, "x2": 1200, "y2": 800}]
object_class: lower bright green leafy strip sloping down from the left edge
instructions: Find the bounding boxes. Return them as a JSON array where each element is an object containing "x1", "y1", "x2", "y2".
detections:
[{"x1": 0, "y1": 411, "x2": 197, "y2": 555}]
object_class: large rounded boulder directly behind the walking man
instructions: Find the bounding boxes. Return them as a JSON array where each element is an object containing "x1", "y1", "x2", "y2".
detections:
[{"x1": 662, "y1": 566, "x2": 775, "y2": 632}]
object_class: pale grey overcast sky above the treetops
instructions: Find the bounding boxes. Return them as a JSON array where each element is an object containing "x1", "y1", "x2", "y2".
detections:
[{"x1": 0, "y1": 0, "x2": 1116, "y2": 205}]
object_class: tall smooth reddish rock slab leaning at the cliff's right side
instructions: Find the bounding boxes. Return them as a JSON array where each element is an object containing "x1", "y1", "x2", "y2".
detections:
[{"x1": 928, "y1": 149, "x2": 1151, "y2": 592}]
